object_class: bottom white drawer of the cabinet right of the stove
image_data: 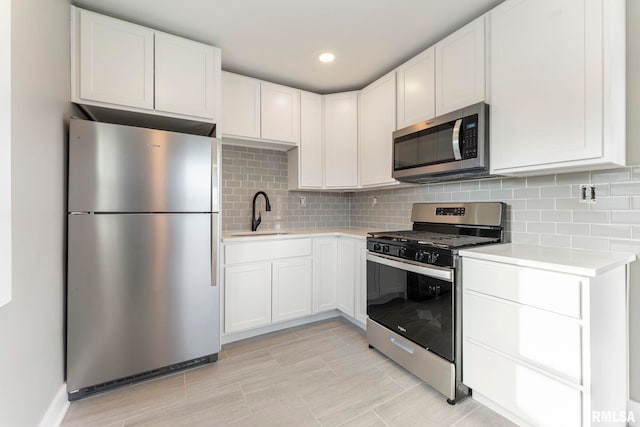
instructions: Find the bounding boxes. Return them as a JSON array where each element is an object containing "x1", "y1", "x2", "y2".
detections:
[{"x1": 462, "y1": 341, "x2": 582, "y2": 427}]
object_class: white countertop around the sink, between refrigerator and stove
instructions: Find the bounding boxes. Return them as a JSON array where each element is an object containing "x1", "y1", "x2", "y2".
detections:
[{"x1": 222, "y1": 228, "x2": 370, "y2": 243}]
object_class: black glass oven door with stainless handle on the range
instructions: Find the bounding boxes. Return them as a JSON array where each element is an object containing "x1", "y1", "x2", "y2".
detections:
[{"x1": 367, "y1": 252, "x2": 455, "y2": 362}]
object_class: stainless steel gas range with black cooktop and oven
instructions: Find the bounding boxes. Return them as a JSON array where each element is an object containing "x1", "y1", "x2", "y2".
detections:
[{"x1": 367, "y1": 202, "x2": 505, "y2": 404}]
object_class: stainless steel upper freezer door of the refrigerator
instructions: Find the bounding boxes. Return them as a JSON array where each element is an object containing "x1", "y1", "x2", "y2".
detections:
[{"x1": 68, "y1": 118, "x2": 215, "y2": 212}]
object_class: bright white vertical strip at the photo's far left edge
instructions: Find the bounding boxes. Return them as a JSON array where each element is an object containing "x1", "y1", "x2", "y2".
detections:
[{"x1": 0, "y1": 0, "x2": 11, "y2": 307}]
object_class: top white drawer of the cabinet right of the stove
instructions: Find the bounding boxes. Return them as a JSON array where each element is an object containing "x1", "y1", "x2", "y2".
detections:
[{"x1": 462, "y1": 258, "x2": 582, "y2": 318}]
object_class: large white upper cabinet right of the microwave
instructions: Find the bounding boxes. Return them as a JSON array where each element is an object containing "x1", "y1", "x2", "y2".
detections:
[{"x1": 490, "y1": 0, "x2": 625, "y2": 174}]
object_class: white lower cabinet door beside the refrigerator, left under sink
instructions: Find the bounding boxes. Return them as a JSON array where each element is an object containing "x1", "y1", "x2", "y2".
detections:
[{"x1": 224, "y1": 262, "x2": 271, "y2": 333}]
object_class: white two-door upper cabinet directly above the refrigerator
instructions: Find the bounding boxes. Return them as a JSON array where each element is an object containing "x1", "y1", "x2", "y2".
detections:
[{"x1": 71, "y1": 6, "x2": 220, "y2": 122}]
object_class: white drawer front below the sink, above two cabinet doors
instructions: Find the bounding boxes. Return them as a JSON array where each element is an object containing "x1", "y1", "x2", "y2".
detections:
[{"x1": 224, "y1": 239, "x2": 311, "y2": 264}]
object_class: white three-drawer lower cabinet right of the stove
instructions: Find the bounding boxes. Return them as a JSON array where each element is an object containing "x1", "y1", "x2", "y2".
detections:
[{"x1": 462, "y1": 251, "x2": 627, "y2": 426}]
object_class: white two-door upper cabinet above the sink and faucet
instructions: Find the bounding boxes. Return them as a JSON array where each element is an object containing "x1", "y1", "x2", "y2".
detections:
[{"x1": 222, "y1": 72, "x2": 300, "y2": 147}]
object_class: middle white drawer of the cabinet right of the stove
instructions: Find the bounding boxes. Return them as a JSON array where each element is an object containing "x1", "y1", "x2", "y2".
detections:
[{"x1": 462, "y1": 291, "x2": 582, "y2": 384}]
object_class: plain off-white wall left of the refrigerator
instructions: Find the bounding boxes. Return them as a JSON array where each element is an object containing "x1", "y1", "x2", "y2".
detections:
[{"x1": 0, "y1": 0, "x2": 70, "y2": 427}]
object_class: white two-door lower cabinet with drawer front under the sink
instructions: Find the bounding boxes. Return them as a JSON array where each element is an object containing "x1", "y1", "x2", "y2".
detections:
[{"x1": 224, "y1": 239, "x2": 312, "y2": 334}]
